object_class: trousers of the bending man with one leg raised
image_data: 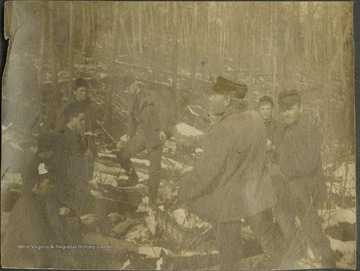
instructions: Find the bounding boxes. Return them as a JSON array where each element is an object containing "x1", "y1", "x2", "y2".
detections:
[{"x1": 118, "y1": 129, "x2": 163, "y2": 202}]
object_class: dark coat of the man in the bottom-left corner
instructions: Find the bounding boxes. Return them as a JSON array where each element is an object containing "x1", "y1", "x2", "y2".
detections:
[{"x1": 1, "y1": 191, "x2": 56, "y2": 268}]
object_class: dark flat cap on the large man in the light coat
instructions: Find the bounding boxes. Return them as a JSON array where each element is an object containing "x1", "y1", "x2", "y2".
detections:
[{"x1": 212, "y1": 76, "x2": 248, "y2": 99}]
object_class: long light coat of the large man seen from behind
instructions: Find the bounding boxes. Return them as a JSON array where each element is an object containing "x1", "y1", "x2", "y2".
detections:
[{"x1": 178, "y1": 105, "x2": 275, "y2": 222}]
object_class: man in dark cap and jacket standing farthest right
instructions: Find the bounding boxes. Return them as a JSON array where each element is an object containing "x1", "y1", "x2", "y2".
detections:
[{"x1": 274, "y1": 90, "x2": 336, "y2": 268}]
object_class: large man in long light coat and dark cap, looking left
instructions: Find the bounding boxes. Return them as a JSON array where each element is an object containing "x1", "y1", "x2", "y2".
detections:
[{"x1": 178, "y1": 77, "x2": 282, "y2": 269}]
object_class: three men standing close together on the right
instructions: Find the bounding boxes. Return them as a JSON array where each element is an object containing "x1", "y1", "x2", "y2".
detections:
[{"x1": 178, "y1": 77, "x2": 336, "y2": 269}]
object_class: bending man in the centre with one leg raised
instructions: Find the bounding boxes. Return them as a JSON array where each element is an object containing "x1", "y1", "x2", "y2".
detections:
[{"x1": 117, "y1": 77, "x2": 167, "y2": 205}]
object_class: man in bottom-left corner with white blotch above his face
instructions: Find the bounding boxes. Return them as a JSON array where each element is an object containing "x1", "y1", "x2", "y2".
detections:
[{"x1": 1, "y1": 163, "x2": 77, "y2": 268}]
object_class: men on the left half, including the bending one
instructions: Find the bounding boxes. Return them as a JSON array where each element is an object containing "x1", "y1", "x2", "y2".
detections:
[{"x1": 2, "y1": 75, "x2": 167, "y2": 268}]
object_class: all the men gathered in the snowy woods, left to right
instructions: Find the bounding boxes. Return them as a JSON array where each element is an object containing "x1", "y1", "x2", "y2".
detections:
[{"x1": 3, "y1": 74, "x2": 336, "y2": 269}]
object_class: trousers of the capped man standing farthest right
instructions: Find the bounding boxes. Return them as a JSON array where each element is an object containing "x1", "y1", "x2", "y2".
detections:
[{"x1": 274, "y1": 181, "x2": 336, "y2": 267}]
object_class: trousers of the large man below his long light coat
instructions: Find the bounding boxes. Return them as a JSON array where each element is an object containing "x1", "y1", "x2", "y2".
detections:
[{"x1": 217, "y1": 209, "x2": 286, "y2": 269}]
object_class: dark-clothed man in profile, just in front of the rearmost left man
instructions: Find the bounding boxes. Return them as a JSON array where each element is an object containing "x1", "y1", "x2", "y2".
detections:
[{"x1": 55, "y1": 103, "x2": 111, "y2": 235}]
